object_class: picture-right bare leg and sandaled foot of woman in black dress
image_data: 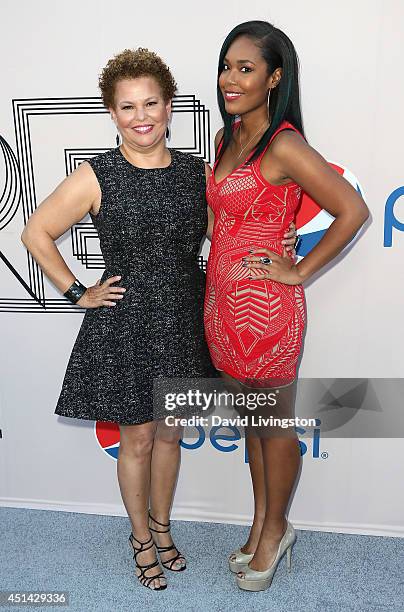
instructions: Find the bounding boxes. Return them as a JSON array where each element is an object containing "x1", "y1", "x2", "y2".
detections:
[{"x1": 150, "y1": 420, "x2": 185, "y2": 570}]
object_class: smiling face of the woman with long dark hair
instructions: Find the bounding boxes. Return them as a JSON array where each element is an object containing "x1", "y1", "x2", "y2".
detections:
[{"x1": 219, "y1": 36, "x2": 281, "y2": 115}]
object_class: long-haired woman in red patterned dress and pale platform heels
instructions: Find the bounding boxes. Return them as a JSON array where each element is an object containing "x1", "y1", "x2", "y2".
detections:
[{"x1": 205, "y1": 21, "x2": 368, "y2": 591}]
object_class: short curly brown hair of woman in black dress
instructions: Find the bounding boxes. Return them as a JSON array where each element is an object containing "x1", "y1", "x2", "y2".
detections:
[{"x1": 98, "y1": 47, "x2": 177, "y2": 108}]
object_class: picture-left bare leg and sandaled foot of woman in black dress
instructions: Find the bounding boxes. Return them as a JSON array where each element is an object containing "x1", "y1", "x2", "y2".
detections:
[{"x1": 117, "y1": 422, "x2": 166, "y2": 588}]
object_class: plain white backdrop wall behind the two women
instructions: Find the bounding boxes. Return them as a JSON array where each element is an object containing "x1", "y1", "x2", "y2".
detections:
[{"x1": 0, "y1": 0, "x2": 404, "y2": 535}]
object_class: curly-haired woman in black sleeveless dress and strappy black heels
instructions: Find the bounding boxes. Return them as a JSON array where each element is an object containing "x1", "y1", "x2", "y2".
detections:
[{"x1": 22, "y1": 49, "x2": 293, "y2": 590}]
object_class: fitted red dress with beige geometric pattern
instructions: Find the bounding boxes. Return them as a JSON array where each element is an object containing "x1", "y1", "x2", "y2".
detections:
[{"x1": 204, "y1": 121, "x2": 306, "y2": 387}]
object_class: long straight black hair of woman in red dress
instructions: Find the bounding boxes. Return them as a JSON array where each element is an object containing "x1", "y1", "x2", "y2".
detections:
[{"x1": 217, "y1": 21, "x2": 305, "y2": 162}]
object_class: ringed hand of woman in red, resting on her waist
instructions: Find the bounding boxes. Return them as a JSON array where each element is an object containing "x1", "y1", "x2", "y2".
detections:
[{"x1": 242, "y1": 249, "x2": 303, "y2": 285}]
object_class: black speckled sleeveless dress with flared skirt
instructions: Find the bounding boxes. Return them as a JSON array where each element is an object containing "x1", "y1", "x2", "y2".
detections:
[{"x1": 55, "y1": 148, "x2": 217, "y2": 425}]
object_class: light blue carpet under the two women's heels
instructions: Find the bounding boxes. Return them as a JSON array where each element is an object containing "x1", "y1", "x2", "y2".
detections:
[{"x1": 0, "y1": 508, "x2": 404, "y2": 612}]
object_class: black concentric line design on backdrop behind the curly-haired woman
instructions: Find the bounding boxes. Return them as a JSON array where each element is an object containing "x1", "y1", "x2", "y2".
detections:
[{"x1": 0, "y1": 95, "x2": 211, "y2": 312}]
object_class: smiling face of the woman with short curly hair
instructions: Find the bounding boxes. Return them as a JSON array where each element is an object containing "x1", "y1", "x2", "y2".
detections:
[{"x1": 109, "y1": 76, "x2": 171, "y2": 150}]
